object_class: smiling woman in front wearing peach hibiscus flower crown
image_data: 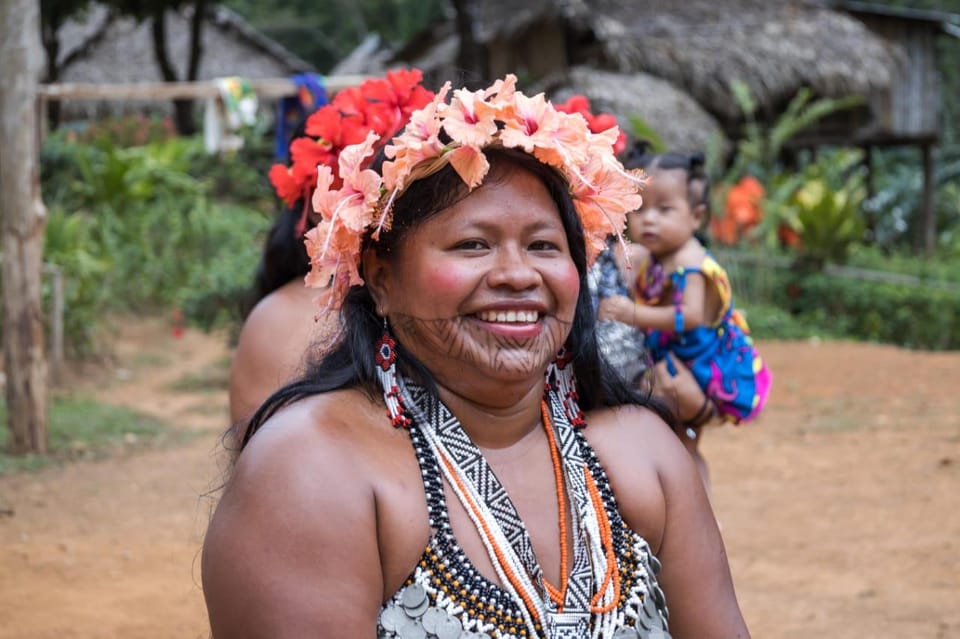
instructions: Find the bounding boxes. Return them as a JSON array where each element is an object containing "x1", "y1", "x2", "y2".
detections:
[{"x1": 203, "y1": 76, "x2": 748, "y2": 638}]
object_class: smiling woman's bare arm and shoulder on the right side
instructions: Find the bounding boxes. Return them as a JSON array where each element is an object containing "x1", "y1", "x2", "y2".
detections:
[{"x1": 584, "y1": 406, "x2": 750, "y2": 639}]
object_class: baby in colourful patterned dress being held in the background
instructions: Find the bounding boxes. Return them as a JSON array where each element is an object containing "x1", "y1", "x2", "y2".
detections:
[{"x1": 598, "y1": 142, "x2": 771, "y2": 496}]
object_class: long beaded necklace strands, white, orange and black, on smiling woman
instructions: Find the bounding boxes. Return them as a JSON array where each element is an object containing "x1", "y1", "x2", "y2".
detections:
[{"x1": 394, "y1": 367, "x2": 620, "y2": 639}]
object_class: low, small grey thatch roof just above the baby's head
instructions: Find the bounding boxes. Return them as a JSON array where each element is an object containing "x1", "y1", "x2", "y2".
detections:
[{"x1": 534, "y1": 67, "x2": 723, "y2": 151}]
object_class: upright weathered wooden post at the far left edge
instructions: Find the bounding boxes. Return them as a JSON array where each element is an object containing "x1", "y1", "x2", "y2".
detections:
[{"x1": 0, "y1": 0, "x2": 47, "y2": 454}]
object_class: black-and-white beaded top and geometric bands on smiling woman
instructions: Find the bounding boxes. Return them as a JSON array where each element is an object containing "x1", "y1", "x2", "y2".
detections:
[{"x1": 386, "y1": 378, "x2": 670, "y2": 639}]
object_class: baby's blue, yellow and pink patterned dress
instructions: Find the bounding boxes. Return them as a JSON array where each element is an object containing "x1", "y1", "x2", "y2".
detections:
[{"x1": 636, "y1": 254, "x2": 772, "y2": 423}]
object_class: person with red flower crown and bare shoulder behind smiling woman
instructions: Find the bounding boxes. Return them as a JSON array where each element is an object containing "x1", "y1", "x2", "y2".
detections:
[{"x1": 229, "y1": 70, "x2": 433, "y2": 430}]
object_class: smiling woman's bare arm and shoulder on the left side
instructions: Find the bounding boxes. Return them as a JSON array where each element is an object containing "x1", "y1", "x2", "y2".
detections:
[{"x1": 202, "y1": 401, "x2": 383, "y2": 639}]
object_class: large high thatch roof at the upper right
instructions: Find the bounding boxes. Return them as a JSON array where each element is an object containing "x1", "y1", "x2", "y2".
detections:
[{"x1": 588, "y1": 0, "x2": 901, "y2": 120}]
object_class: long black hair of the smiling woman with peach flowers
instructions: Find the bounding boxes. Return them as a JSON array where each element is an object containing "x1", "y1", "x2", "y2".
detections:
[{"x1": 242, "y1": 149, "x2": 672, "y2": 446}]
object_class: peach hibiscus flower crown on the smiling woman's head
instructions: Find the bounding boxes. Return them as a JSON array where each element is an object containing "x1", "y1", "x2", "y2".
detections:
[{"x1": 284, "y1": 72, "x2": 645, "y2": 309}]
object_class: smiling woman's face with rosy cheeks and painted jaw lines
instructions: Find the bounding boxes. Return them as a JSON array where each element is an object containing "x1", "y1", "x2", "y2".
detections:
[{"x1": 374, "y1": 164, "x2": 579, "y2": 394}]
